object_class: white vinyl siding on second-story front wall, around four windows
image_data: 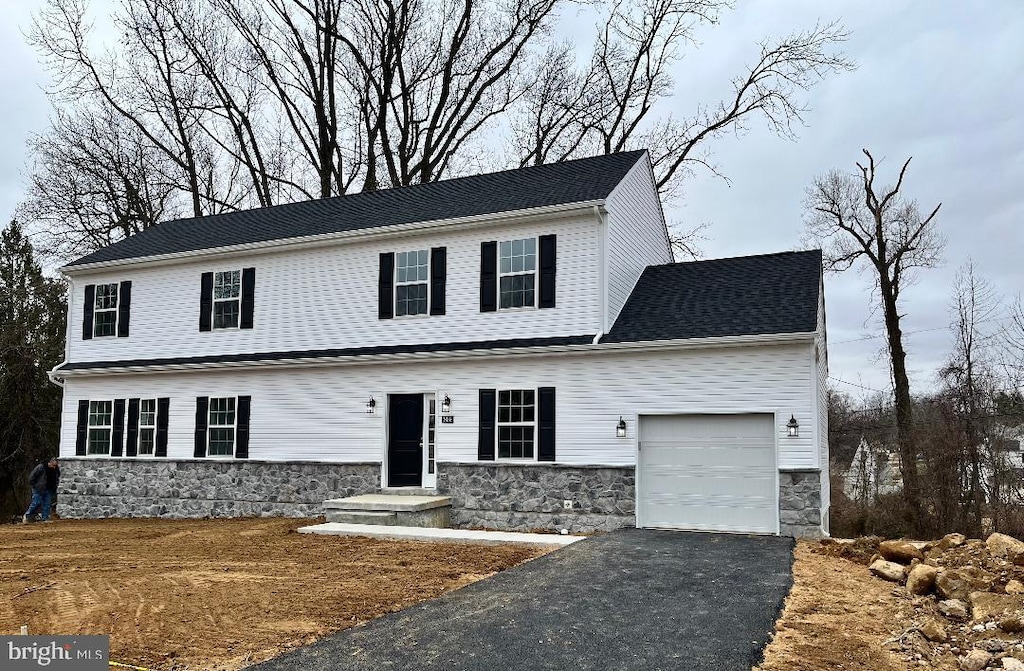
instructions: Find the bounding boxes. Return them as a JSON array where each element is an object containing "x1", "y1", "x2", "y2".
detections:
[{"x1": 69, "y1": 214, "x2": 601, "y2": 362}]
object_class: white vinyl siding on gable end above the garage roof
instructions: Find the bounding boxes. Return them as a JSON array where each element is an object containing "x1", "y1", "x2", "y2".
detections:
[{"x1": 606, "y1": 155, "x2": 673, "y2": 328}]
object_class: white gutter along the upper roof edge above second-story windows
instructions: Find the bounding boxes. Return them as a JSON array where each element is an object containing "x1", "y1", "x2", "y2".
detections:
[{"x1": 59, "y1": 200, "x2": 604, "y2": 275}]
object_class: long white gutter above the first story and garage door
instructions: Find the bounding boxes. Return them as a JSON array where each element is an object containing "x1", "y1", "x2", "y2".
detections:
[{"x1": 50, "y1": 332, "x2": 815, "y2": 378}]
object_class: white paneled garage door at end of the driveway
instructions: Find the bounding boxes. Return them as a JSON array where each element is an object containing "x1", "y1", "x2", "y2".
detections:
[{"x1": 637, "y1": 414, "x2": 778, "y2": 534}]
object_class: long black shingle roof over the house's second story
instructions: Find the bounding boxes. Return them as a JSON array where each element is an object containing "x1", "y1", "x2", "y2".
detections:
[{"x1": 65, "y1": 151, "x2": 646, "y2": 269}]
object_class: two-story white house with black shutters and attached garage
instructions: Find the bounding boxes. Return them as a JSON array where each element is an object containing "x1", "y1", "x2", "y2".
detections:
[{"x1": 51, "y1": 152, "x2": 828, "y2": 535}]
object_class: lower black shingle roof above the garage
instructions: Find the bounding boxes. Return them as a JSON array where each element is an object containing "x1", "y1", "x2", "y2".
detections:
[{"x1": 601, "y1": 249, "x2": 821, "y2": 342}]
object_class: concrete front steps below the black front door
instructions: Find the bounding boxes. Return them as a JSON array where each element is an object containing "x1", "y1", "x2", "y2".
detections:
[{"x1": 324, "y1": 491, "x2": 452, "y2": 529}]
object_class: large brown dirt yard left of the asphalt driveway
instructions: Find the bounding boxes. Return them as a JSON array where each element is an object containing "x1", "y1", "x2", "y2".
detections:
[{"x1": 0, "y1": 519, "x2": 547, "y2": 671}]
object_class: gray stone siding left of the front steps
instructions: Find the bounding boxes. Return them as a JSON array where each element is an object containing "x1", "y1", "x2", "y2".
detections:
[{"x1": 57, "y1": 459, "x2": 381, "y2": 517}]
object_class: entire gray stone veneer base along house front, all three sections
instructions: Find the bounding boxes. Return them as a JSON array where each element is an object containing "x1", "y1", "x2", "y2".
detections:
[{"x1": 58, "y1": 459, "x2": 821, "y2": 538}]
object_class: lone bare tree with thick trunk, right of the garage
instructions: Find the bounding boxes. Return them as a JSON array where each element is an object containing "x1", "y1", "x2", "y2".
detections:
[{"x1": 805, "y1": 150, "x2": 945, "y2": 525}]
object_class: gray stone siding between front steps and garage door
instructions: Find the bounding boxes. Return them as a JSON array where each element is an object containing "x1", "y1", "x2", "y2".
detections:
[{"x1": 437, "y1": 463, "x2": 636, "y2": 533}]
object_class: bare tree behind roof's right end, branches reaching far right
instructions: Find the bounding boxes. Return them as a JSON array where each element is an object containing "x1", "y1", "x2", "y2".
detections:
[{"x1": 516, "y1": 0, "x2": 854, "y2": 193}]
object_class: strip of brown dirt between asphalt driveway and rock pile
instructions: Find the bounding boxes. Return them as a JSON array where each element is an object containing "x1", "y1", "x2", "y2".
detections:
[{"x1": 757, "y1": 541, "x2": 913, "y2": 671}]
